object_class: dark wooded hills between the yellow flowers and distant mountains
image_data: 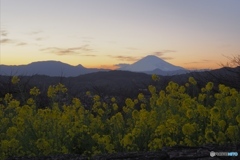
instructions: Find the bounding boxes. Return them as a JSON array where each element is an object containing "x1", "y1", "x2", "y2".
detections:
[{"x1": 0, "y1": 67, "x2": 240, "y2": 108}]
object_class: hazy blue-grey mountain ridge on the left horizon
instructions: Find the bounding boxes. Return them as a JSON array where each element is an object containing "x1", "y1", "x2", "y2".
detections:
[{"x1": 0, "y1": 61, "x2": 108, "y2": 77}]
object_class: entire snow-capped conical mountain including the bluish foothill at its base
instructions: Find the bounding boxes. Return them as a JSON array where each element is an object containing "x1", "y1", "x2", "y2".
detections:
[{"x1": 118, "y1": 55, "x2": 188, "y2": 75}]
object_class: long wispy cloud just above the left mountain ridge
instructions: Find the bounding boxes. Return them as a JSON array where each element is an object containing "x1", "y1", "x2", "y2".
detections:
[{"x1": 40, "y1": 44, "x2": 93, "y2": 56}]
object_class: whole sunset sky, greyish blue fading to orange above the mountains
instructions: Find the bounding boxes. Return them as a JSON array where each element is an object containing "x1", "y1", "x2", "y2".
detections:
[{"x1": 0, "y1": 0, "x2": 240, "y2": 69}]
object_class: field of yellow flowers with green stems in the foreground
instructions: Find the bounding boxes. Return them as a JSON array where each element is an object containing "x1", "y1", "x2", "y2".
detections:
[{"x1": 0, "y1": 75, "x2": 240, "y2": 159}]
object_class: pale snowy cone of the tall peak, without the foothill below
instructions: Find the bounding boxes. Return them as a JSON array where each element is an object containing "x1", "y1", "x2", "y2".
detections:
[{"x1": 119, "y1": 55, "x2": 185, "y2": 72}]
